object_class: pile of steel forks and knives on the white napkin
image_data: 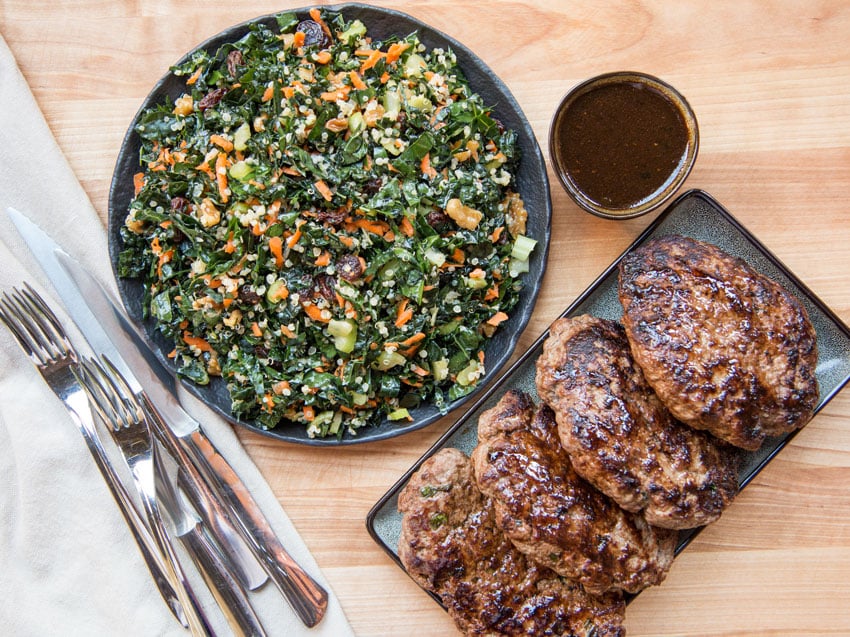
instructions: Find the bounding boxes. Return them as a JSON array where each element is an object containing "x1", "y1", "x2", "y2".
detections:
[{"x1": 0, "y1": 209, "x2": 328, "y2": 635}]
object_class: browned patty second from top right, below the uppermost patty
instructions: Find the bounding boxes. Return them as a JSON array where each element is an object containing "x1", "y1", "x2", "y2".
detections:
[{"x1": 536, "y1": 315, "x2": 738, "y2": 529}]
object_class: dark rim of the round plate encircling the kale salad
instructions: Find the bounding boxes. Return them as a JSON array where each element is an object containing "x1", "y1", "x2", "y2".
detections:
[{"x1": 107, "y1": 2, "x2": 553, "y2": 448}]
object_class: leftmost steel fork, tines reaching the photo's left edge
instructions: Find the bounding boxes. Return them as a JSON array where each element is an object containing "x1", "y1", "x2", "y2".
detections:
[{"x1": 0, "y1": 283, "x2": 189, "y2": 628}]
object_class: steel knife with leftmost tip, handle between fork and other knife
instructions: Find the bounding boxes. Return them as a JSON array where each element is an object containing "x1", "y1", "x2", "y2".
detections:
[{"x1": 6, "y1": 208, "x2": 268, "y2": 590}]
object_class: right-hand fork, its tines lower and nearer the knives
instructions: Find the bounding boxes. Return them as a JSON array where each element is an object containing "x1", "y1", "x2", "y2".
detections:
[{"x1": 78, "y1": 356, "x2": 214, "y2": 636}]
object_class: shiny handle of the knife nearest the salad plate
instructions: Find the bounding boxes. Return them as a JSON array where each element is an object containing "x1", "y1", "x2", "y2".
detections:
[{"x1": 179, "y1": 429, "x2": 328, "y2": 627}]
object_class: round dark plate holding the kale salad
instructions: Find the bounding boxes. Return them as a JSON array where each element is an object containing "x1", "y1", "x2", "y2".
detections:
[{"x1": 108, "y1": 4, "x2": 552, "y2": 446}]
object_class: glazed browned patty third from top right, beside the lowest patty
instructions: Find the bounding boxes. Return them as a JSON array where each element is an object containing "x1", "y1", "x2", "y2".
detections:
[{"x1": 472, "y1": 391, "x2": 676, "y2": 594}]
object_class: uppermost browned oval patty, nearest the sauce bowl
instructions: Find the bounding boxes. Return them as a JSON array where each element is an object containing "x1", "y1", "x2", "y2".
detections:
[{"x1": 619, "y1": 236, "x2": 818, "y2": 450}]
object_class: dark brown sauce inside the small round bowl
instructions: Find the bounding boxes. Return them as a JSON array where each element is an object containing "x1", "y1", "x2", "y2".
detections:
[{"x1": 554, "y1": 82, "x2": 688, "y2": 208}]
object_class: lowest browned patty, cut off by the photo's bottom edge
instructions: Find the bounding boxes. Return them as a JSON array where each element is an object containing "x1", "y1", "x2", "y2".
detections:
[{"x1": 398, "y1": 448, "x2": 625, "y2": 637}]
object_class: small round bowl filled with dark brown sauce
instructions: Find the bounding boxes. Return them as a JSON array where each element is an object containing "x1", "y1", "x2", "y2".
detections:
[{"x1": 549, "y1": 71, "x2": 699, "y2": 219}]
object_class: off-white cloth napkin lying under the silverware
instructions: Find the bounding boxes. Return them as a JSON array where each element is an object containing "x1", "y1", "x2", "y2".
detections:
[{"x1": 0, "y1": 36, "x2": 353, "y2": 637}]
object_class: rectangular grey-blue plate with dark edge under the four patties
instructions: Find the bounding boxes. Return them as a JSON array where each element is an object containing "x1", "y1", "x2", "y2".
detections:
[{"x1": 366, "y1": 190, "x2": 850, "y2": 601}]
